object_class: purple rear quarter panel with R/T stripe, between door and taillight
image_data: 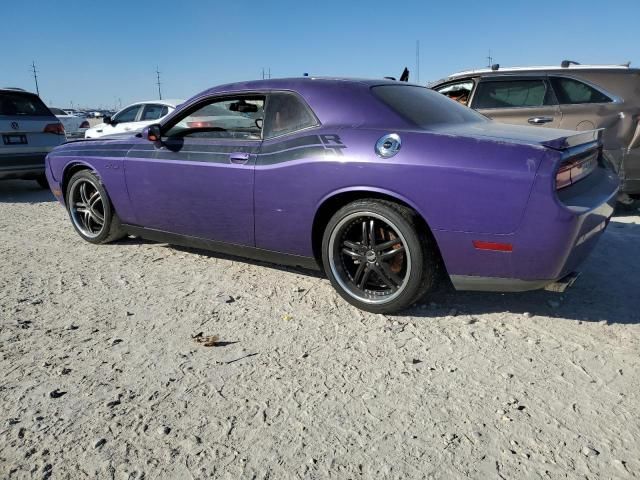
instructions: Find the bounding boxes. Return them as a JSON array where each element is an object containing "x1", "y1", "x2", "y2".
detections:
[{"x1": 255, "y1": 128, "x2": 546, "y2": 255}]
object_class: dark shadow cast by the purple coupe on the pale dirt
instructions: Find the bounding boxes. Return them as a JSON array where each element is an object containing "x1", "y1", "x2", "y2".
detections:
[{"x1": 116, "y1": 215, "x2": 640, "y2": 324}]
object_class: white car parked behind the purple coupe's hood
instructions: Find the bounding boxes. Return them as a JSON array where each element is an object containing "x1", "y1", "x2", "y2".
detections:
[{"x1": 85, "y1": 100, "x2": 184, "y2": 138}]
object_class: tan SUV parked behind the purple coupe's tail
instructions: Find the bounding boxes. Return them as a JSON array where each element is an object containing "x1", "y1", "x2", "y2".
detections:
[{"x1": 430, "y1": 60, "x2": 640, "y2": 202}]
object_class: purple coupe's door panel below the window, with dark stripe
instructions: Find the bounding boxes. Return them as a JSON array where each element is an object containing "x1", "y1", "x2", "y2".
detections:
[{"x1": 125, "y1": 138, "x2": 260, "y2": 246}]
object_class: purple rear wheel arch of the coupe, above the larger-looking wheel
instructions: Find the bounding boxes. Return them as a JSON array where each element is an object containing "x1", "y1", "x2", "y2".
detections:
[{"x1": 311, "y1": 187, "x2": 446, "y2": 272}]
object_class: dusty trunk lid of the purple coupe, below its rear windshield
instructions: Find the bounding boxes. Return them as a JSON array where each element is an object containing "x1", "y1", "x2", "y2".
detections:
[{"x1": 434, "y1": 121, "x2": 601, "y2": 150}]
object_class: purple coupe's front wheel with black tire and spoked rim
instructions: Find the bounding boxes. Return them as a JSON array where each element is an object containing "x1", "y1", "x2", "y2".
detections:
[{"x1": 65, "y1": 170, "x2": 126, "y2": 244}]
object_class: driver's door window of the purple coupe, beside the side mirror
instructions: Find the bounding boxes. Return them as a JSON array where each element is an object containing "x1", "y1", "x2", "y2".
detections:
[{"x1": 166, "y1": 96, "x2": 264, "y2": 140}]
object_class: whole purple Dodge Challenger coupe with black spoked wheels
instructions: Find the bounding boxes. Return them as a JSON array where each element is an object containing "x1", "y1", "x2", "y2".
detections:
[{"x1": 46, "y1": 78, "x2": 618, "y2": 313}]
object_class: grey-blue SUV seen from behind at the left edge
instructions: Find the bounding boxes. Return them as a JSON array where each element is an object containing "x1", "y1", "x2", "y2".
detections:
[{"x1": 0, "y1": 88, "x2": 65, "y2": 188}]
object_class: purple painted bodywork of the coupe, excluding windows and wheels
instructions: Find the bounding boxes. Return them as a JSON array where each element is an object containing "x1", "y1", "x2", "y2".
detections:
[{"x1": 47, "y1": 78, "x2": 617, "y2": 288}]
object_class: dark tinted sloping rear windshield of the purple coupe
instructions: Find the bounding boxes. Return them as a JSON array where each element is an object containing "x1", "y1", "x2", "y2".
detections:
[{"x1": 371, "y1": 85, "x2": 487, "y2": 128}]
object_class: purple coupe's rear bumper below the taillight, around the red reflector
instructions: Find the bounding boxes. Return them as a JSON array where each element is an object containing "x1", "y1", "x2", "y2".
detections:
[{"x1": 442, "y1": 160, "x2": 619, "y2": 292}]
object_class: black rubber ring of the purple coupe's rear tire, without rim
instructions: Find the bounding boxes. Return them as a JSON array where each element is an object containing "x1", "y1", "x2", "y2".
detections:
[{"x1": 322, "y1": 200, "x2": 425, "y2": 313}]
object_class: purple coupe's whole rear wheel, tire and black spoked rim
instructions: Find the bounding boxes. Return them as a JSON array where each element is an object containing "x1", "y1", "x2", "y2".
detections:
[{"x1": 322, "y1": 199, "x2": 439, "y2": 313}]
